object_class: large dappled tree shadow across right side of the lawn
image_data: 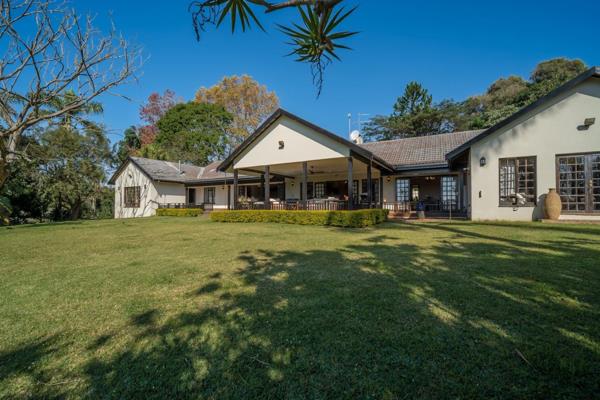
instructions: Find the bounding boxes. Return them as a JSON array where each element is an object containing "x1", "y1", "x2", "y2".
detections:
[{"x1": 11, "y1": 225, "x2": 600, "y2": 399}]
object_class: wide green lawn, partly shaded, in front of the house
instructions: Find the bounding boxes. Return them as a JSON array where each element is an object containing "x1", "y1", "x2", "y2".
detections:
[{"x1": 0, "y1": 217, "x2": 600, "y2": 399}]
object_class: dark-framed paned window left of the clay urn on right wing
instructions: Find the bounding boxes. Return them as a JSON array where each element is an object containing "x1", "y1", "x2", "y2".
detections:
[{"x1": 499, "y1": 157, "x2": 537, "y2": 207}]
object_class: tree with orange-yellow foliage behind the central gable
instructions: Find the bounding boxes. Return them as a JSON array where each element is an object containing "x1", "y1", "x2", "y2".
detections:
[{"x1": 195, "y1": 75, "x2": 279, "y2": 146}]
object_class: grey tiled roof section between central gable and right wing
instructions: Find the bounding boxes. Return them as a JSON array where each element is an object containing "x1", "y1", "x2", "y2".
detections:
[{"x1": 360, "y1": 130, "x2": 483, "y2": 170}]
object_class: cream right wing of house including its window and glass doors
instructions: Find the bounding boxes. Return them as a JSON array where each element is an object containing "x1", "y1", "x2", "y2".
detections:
[{"x1": 469, "y1": 76, "x2": 600, "y2": 221}]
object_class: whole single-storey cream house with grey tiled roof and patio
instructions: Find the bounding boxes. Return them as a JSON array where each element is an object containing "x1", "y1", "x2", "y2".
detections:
[{"x1": 110, "y1": 67, "x2": 600, "y2": 221}]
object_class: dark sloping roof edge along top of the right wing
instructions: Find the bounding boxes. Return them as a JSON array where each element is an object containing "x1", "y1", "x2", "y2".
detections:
[{"x1": 446, "y1": 67, "x2": 600, "y2": 162}]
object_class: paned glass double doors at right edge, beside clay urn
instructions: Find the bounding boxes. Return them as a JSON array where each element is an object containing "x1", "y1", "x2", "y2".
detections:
[{"x1": 556, "y1": 153, "x2": 600, "y2": 214}]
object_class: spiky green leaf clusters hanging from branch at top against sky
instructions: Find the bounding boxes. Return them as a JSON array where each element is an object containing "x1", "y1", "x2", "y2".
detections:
[{"x1": 189, "y1": 0, "x2": 357, "y2": 97}]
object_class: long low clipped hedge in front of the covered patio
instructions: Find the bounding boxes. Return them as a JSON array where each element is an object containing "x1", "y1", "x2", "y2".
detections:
[{"x1": 210, "y1": 209, "x2": 388, "y2": 228}]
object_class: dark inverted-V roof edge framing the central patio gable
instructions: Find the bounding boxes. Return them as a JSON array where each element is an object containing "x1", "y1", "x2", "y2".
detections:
[{"x1": 218, "y1": 108, "x2": 393, "y2": 171}]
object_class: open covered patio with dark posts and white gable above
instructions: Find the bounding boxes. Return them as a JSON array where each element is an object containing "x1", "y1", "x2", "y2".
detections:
[{"x1": 219, "y1": 110, "x2": 393, "y2": 210}]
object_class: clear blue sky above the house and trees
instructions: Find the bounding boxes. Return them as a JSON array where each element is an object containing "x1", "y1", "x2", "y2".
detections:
[{"x1": 75, "y1": 0, "x2": 600, "y2": 144}]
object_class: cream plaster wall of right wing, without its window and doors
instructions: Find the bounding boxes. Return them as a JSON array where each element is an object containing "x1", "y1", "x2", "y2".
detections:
[{"x1": 470, "y1": 78, "x2": 600, "y2": 221}]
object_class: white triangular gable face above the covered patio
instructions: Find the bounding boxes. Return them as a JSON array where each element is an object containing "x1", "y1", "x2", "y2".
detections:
[{"x1": 234, "y1": 116, "x2": 350, "y2": 169}]
